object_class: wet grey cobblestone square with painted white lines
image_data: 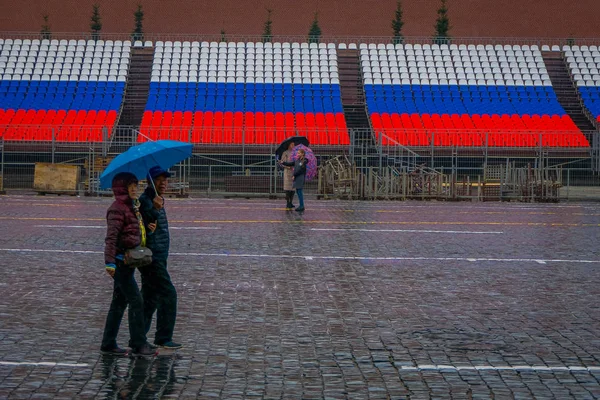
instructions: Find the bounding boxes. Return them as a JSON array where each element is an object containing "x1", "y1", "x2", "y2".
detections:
[{"x1": 0, "y1": 196, "x2": 600, "y2": 399}]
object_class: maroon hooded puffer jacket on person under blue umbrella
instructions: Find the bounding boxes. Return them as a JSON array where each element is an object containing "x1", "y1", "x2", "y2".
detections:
[{"x1": 104, "y1": 174, "x2": 142, "y2": 264}]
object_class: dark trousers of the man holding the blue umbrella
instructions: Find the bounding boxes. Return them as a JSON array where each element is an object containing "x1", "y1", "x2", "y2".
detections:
[{"x1": 140, "y1": 259, "x2": 177, "y2": 345}]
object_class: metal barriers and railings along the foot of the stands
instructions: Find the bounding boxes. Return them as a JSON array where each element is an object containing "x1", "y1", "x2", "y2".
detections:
[{"x1": 0, "y1": 128, "x2": 600, "y2": 201}]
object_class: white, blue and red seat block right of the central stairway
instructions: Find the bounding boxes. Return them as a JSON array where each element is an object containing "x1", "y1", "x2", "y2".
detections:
[{"x1": 360, "y1": 44, "x2": 589, "y2": 147}]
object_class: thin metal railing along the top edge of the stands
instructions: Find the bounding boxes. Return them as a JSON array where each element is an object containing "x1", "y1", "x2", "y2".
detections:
[{"x1": 0, "y1": 32, "x2": 600, "y2": 47}]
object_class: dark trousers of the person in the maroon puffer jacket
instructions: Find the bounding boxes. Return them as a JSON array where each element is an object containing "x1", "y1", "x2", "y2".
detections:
[{"x1": 102, "y1": 261, "x2": 146, "y2": 349}]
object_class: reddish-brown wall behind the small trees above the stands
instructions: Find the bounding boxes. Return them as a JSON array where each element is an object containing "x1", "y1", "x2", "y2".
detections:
[{"x1": 0, "y1": 0, "x2": 600, "y2": 38}]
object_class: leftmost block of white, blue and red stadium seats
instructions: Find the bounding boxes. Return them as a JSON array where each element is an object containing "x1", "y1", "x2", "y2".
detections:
[{"x1": 0, "y1": 39, "x2": 126, "y2": 142}]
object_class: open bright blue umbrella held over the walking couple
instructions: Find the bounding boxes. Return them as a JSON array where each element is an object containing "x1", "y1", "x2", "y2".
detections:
[{"x1": 100, "y1": 140, "x2": 193, "y2": 189}]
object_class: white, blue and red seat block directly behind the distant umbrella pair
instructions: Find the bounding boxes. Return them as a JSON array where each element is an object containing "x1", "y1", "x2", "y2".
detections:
[{"x1": 139, "y1": 41, "x2": 350, "y2": 145}]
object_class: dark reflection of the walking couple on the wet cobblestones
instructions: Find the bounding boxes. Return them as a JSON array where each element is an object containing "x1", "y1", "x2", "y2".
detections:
[{"x1": 101, "y1": 355, "x2": 177, "y2": 399}]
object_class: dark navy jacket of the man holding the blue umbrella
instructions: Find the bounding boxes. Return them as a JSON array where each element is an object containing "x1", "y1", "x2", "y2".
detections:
[{"x1": 140, "y1": 187, "x2": 171, "y2": 261}]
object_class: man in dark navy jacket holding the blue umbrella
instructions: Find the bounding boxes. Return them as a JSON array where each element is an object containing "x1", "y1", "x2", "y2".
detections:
[{"x1": 140, "y1": 167, "x2": 181, "y2": 349}]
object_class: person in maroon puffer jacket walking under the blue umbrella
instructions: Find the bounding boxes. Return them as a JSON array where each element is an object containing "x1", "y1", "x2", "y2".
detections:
[{"x1": 100, "y1": 172, "x2": 156, "y2": 356}]
